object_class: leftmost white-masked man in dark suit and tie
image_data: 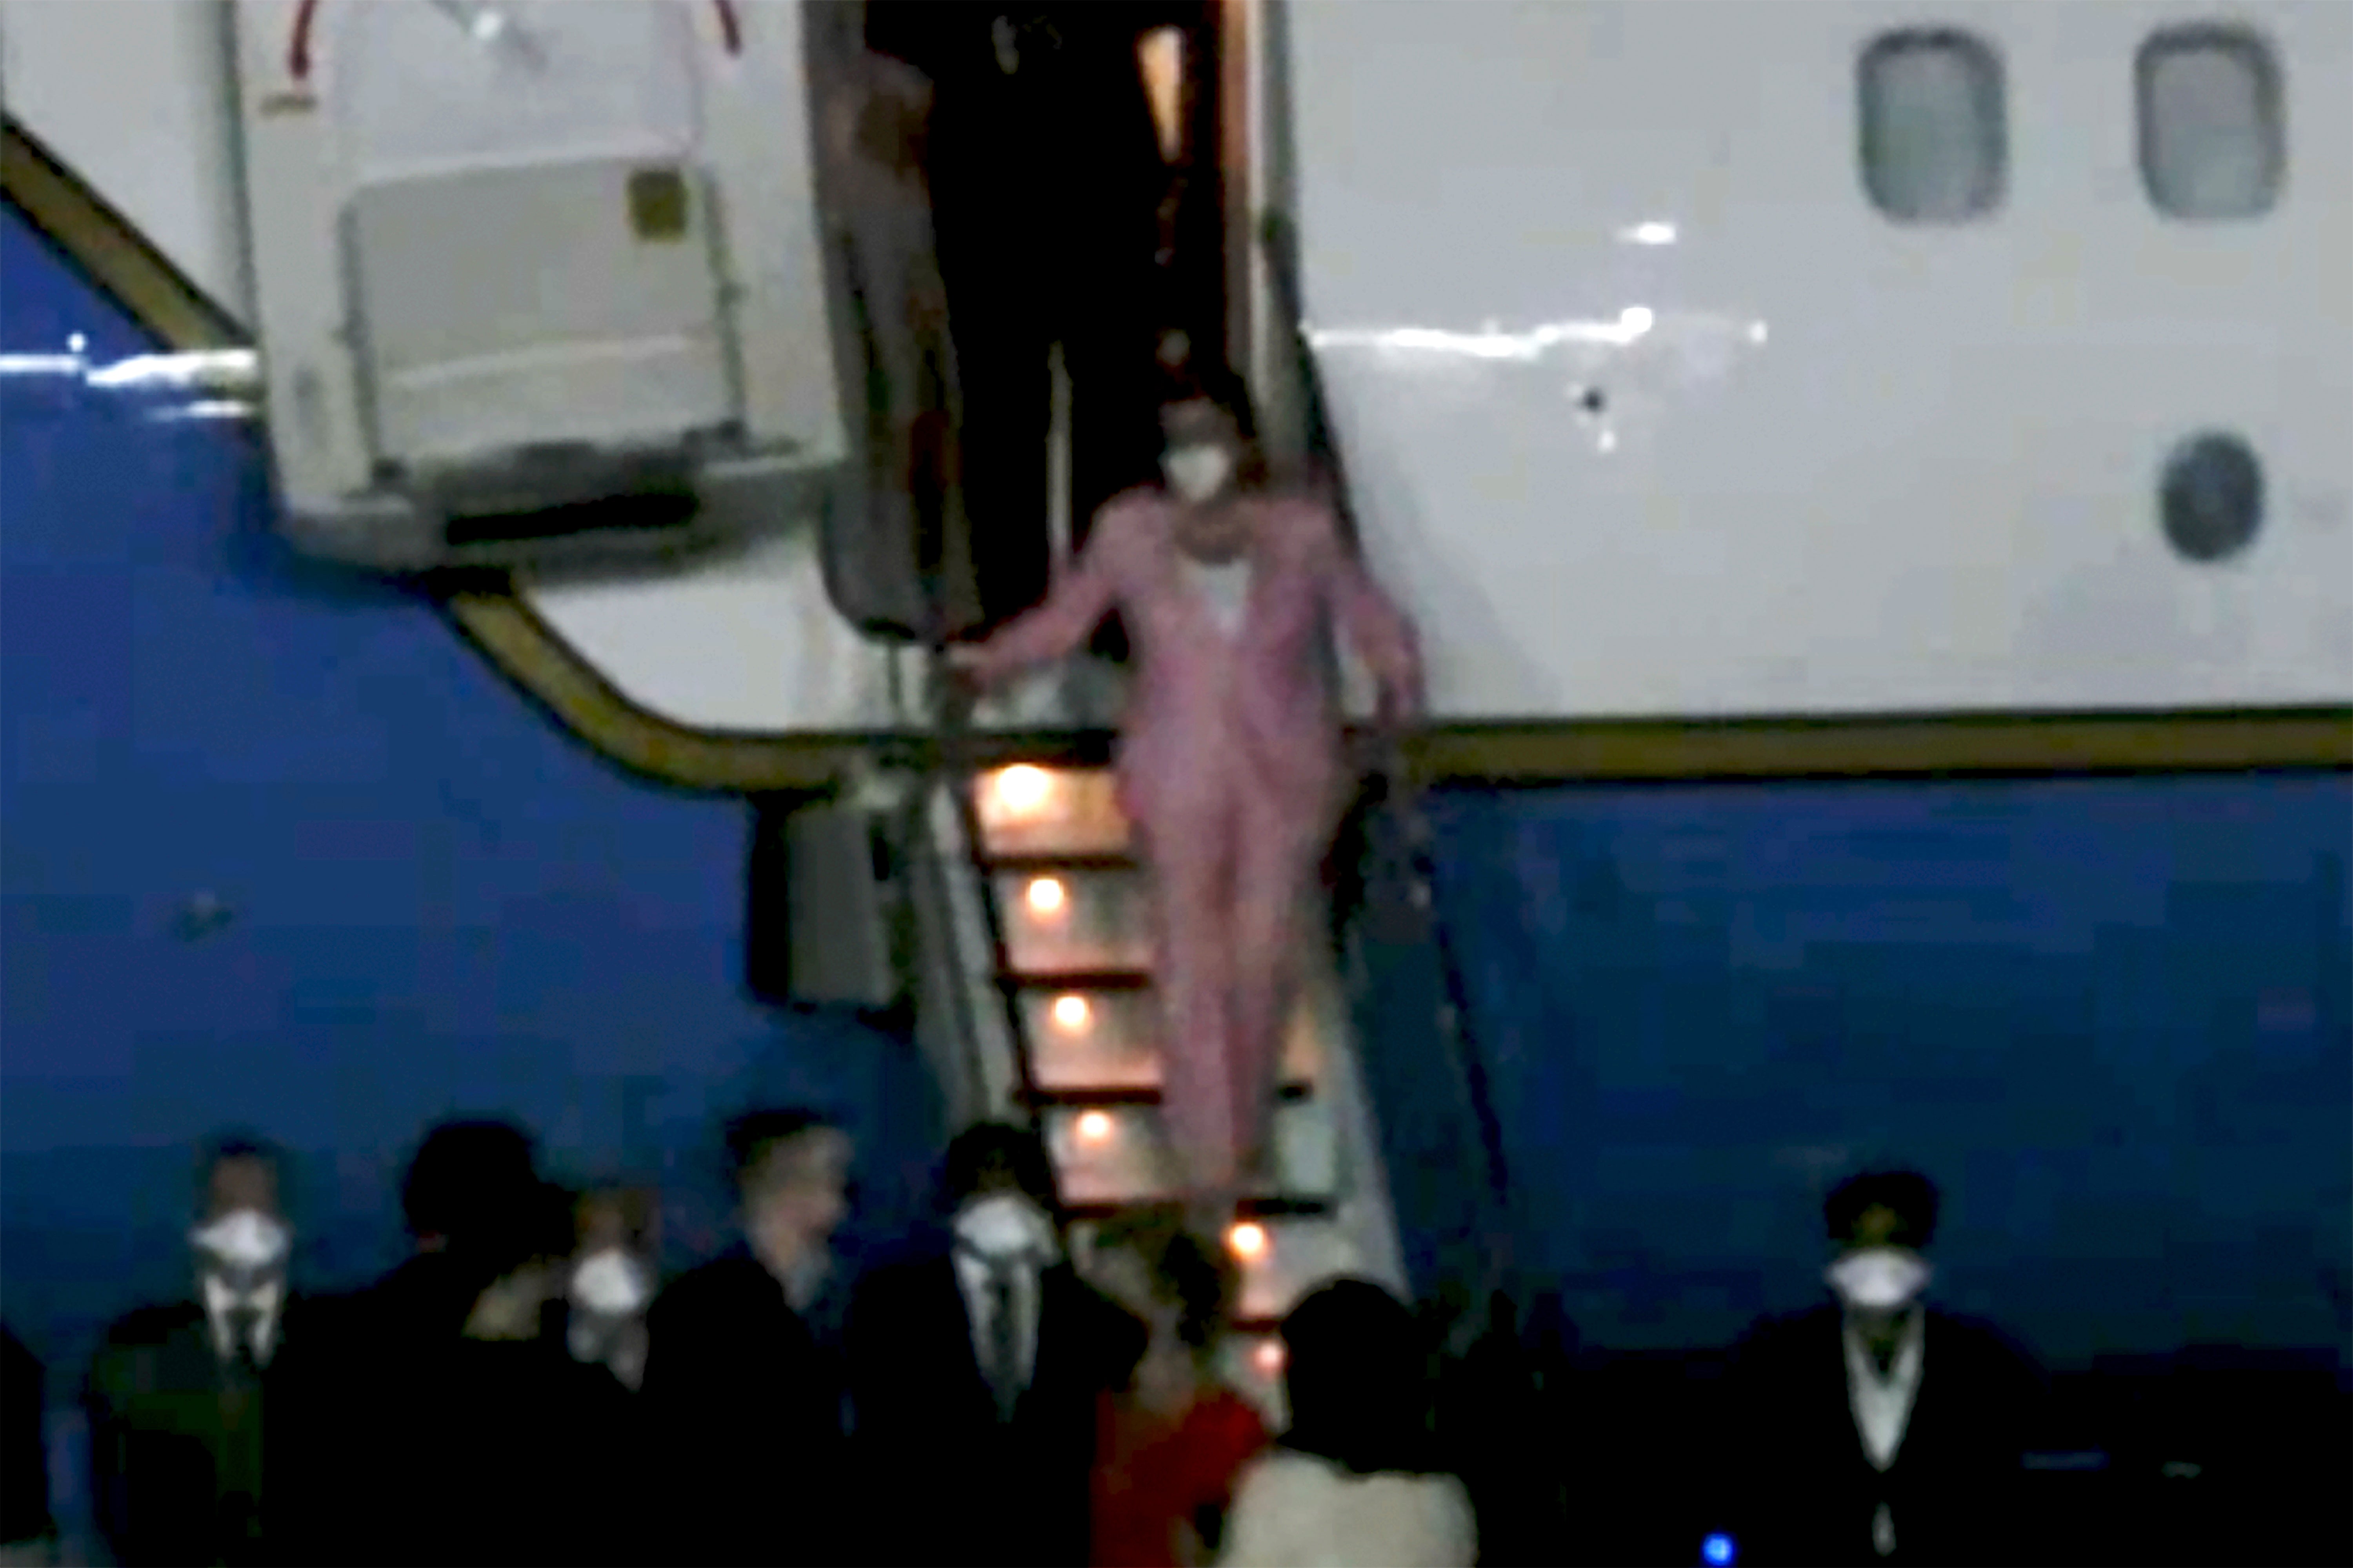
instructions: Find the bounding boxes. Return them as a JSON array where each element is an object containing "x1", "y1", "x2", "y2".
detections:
[{"x1": 85, "y1": 1137, "x2": 322, "y2": 1563}]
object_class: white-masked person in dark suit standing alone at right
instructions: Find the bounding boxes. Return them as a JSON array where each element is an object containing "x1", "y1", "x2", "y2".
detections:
[{"x1": 1729, "y1": 1170, "x2": 2042, "y2": 1566}]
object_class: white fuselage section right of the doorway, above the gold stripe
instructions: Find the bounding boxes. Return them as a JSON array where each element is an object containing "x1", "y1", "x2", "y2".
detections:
[{"x1": 1292, "y1": 0, "x2": 2353, "y2": 718}]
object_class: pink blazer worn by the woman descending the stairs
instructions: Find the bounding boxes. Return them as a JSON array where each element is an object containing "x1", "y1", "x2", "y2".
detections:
[{"x1": 972, "y1": 490, "x2": 1421, "y2": 824}]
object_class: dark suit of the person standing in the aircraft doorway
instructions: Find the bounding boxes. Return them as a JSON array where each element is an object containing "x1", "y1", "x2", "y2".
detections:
[{"x1": 866, "y1": 0, "x2": 1176, "y2": 621}]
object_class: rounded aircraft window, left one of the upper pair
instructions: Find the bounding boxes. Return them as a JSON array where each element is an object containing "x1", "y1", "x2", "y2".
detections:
[{"x1": 1857, "y1": 28, "x2": 2009, "y2": 223}]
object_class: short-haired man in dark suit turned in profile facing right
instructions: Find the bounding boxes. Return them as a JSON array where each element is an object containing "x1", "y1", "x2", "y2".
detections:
[{"x1": 642, "y1": 1109, "x2": 852, "y2": 1563}]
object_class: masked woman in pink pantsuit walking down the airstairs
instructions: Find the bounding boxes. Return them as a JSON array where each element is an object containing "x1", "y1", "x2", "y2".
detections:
[{"x1": 951, "y1": 398, "x2": 1421, "y2": 1222}]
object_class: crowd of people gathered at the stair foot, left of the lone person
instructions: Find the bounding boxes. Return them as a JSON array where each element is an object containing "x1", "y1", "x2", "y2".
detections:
[{"x1": 7, "y1": 1109, "x2": 1475, "y2": 1566}]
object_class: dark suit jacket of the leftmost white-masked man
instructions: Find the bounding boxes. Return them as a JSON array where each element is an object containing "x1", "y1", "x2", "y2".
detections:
[{"x1": 87, "y1": 1297, "x2": 325, "y2": 1563}]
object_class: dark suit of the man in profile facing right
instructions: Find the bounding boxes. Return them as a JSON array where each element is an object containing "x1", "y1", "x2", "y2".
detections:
[{"x1": 642, "y1": 1245, "x2": 852, "y2": 1563}]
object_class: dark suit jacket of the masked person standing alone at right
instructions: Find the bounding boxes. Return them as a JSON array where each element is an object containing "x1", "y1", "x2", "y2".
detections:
[{"x1": 1727, "y1": 1307, "x2": 2042, "y2": 1568}]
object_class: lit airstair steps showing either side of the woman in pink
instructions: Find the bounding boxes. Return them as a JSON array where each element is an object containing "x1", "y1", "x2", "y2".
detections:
[{"x1": 925, "y1": 725, "x2": 1407, "y2": 1422}]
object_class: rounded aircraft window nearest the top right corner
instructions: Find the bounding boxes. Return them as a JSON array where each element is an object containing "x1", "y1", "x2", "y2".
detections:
[{"x1": 2137, "y1": 26, "x2": 2287, "y2": 223}]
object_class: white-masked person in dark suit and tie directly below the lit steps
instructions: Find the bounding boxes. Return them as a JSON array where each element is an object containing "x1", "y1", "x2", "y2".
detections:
[{"x1": 849, "y1": 1123, "x2": 1148, "y2": 1568}]
